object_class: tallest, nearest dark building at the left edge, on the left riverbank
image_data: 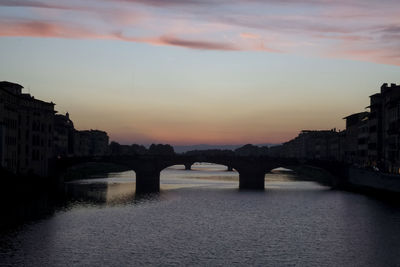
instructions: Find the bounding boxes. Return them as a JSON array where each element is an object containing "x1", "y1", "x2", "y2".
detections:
[{"x1": 0, "y1": 81, "x2": 55, "y2": 176}]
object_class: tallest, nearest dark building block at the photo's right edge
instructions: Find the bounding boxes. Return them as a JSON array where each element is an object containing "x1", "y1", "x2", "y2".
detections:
[{"x1": 346, "y1": 83, "x2": 400, "y2": 174}]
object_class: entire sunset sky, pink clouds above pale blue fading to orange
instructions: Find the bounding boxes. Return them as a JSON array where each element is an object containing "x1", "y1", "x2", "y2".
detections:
[{"x1": 0, "y1": 0, "x2": 400, "y2": 145}]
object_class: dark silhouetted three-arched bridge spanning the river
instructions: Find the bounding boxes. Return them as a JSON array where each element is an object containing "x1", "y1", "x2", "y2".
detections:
[{"x1": 52, "y1": 154, "x2": 343, "y2": 192}]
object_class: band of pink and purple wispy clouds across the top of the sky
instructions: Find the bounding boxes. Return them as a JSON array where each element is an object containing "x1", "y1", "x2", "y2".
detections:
[{"x1": 0, "y1": 0, "x2": 400, "y2": 65}]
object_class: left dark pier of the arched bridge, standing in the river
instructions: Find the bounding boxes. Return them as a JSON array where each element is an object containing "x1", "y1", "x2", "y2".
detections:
[{"x1": 136, "y1": 170, "x2": 160, "y2": 193}]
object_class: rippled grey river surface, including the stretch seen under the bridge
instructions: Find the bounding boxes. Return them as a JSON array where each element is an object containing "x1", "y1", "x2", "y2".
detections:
[{"x1": 0, "y1": 165, "x2": 400, "y2": 266}]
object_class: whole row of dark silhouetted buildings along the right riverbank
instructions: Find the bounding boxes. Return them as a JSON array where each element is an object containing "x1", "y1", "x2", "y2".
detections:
[{"x1": 269, "y1": 83, "x2": 400, "y2": 174}]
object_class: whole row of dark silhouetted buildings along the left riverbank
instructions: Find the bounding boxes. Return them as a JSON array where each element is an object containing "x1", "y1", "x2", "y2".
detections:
[{"x1": 0, "y1": 81, "x2": 109, "y2": 176}]
